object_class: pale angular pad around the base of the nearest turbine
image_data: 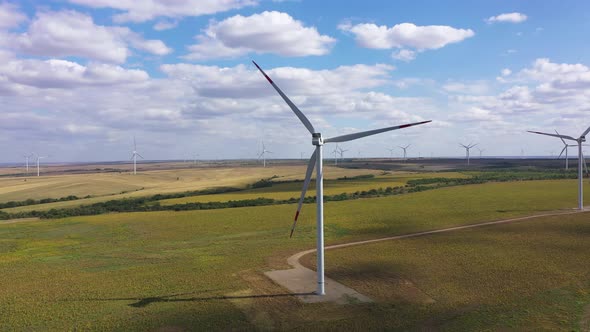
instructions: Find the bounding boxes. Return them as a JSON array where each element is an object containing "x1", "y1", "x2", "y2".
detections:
[{"x1": 264, "y1": 266, "x2": 372, "y2": 304}]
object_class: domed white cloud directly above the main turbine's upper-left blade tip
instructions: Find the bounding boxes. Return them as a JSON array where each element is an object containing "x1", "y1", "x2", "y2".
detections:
[{"x1": 184, "y1": 11, "x2": 335, "y2": 60}]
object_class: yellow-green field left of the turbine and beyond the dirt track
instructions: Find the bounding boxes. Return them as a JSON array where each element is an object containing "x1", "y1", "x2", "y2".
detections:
[{"x1": 0, "y1": 180, "x2": 590, "y2": 330}]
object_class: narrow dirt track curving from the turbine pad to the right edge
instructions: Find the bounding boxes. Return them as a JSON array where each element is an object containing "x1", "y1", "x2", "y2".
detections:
[{"x1": 274, "y1": 207, "x2": 590, "y2": 302}]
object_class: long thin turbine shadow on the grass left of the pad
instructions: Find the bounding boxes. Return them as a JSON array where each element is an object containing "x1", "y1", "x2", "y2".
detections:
[{"x1": 85, "y1": 292, "x2": 315, "y2": 308}]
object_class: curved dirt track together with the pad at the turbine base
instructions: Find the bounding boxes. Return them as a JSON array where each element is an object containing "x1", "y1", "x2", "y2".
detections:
[{"x1": 265, "y1": 207, "x2": 588, "y2": 303}]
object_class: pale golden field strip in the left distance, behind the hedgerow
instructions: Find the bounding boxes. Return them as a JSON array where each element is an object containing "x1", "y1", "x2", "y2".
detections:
[{"x1": 0, "y1": 166, "x2": 381, "y2": 212}]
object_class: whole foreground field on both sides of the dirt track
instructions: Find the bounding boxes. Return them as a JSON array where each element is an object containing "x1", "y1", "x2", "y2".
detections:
[{"x1": 0, "y1": 176, "x2": 590, "y2": 330}]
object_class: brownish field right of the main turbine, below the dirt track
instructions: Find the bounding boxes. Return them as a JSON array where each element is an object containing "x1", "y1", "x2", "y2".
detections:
[{"x1": 305, "y1": 213, "x2": 590, "y2": 331}]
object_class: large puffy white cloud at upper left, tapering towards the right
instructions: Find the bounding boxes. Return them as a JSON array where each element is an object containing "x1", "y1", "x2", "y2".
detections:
[{"x1": 12, "y1": 10, "x2": 171, "y2": 63}]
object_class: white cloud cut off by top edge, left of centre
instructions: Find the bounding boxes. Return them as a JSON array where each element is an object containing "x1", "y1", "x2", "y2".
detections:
[{"x1": 69, "y1": 0, "x2": 258, "y2": 23}]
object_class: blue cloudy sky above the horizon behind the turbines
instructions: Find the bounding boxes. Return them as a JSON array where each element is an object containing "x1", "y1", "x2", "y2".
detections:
[{"x1": 0, "y1": 0, "x2": 590, "y2": 162}]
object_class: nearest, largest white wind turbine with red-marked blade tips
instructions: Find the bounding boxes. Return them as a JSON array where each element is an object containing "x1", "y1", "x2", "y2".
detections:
[{"x1": 252, "y1": 61, "x2": 431, "y2": 295}]
